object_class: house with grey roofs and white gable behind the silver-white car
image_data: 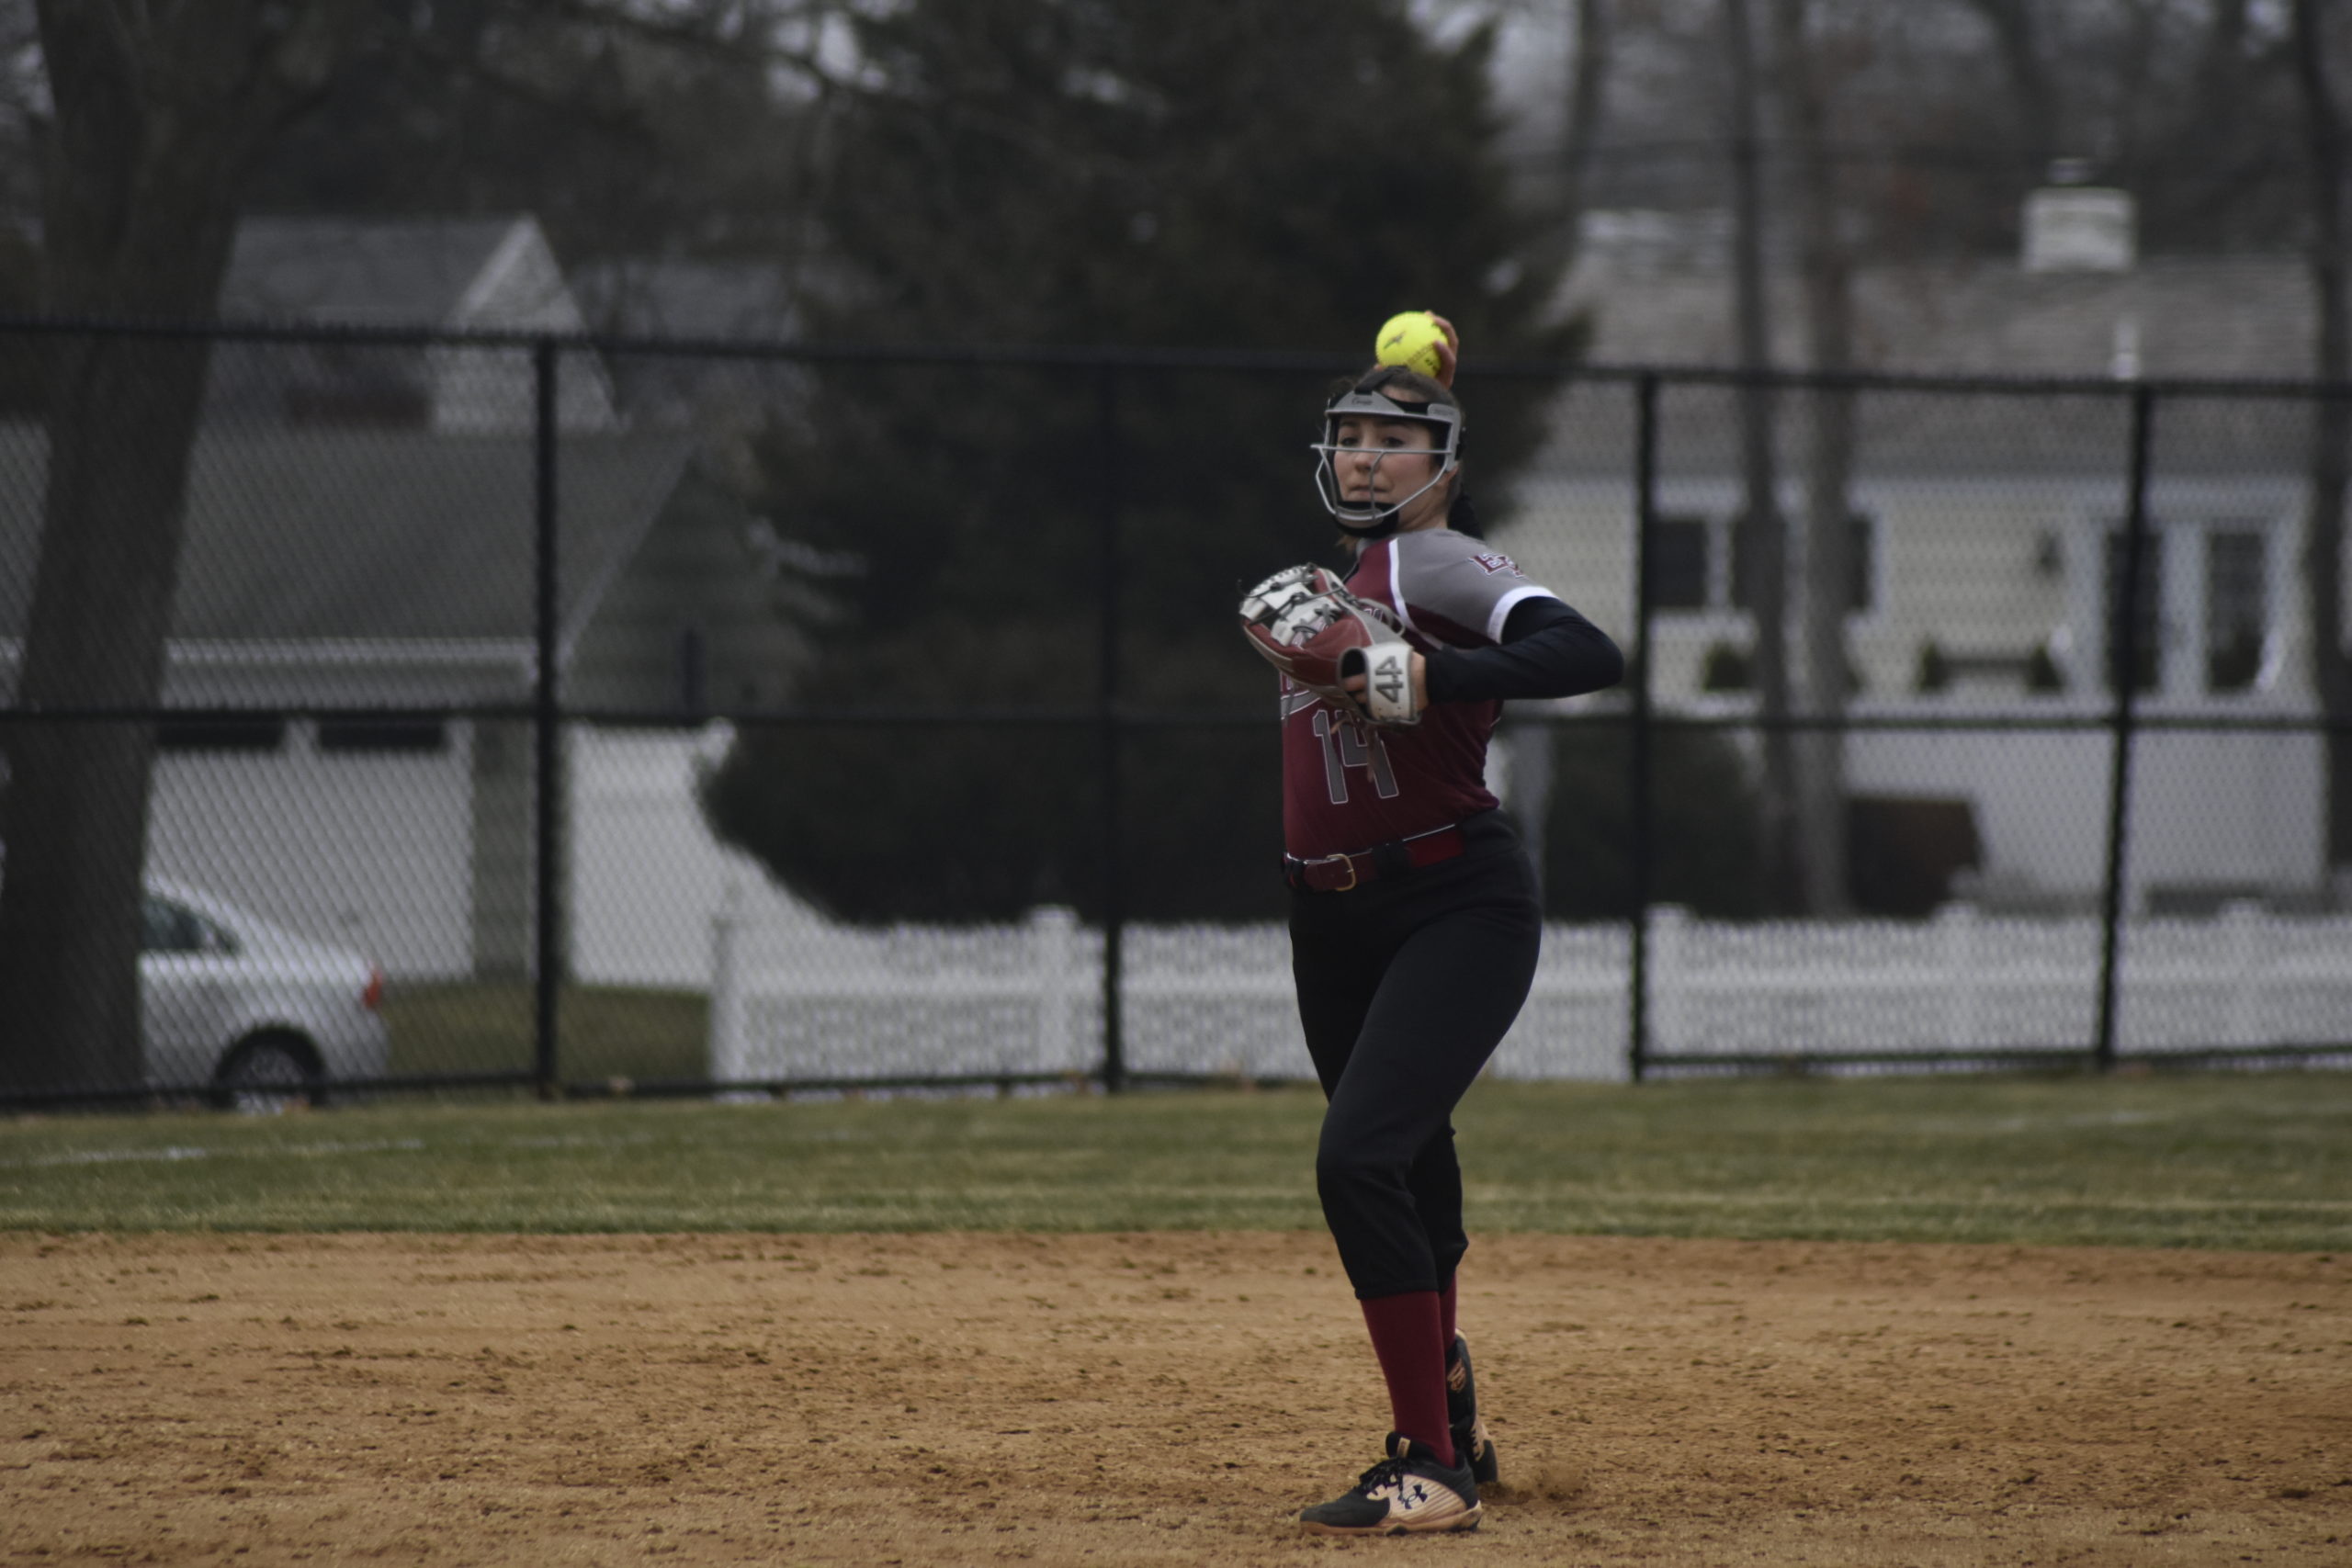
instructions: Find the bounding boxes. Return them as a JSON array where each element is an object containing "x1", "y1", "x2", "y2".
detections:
[{"x1": 0, "y1": 216, "x2": 797, "y2": 978}]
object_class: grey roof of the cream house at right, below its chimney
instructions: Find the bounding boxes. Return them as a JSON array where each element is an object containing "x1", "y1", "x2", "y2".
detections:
[{"x1": 1523, "y1": 252, "x2": 2310, "y2": 482}]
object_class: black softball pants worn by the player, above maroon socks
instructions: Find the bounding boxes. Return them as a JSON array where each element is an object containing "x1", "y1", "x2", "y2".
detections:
[{"x1": 1291, "y1": 811, "x2": 1543, "y2": 1300}]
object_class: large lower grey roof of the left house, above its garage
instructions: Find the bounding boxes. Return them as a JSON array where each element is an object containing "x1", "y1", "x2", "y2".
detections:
[{"x1": 0, "y1": 423, "x2": 689, "y2": 644}]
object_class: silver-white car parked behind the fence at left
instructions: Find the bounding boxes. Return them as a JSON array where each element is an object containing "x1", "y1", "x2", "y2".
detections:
[{"x1": 139, "y1": 882, "x2": 390, "y2": 1110}]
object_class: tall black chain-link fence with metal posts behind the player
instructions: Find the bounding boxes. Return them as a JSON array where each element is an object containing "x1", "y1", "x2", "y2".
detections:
[{"x1": 0, "y1": 322, "x2": 2352, "y2": 1105}]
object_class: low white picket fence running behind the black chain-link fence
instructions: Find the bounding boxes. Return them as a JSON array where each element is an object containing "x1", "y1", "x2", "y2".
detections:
[{"x1": 710, "y1": 905, "x2": 2352, "y2": 1081}]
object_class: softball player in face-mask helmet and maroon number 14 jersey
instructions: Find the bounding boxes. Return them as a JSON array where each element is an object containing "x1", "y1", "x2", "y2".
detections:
[{"x1": 1244, "y1": 333, "x2": 1625, "y2": 1535}]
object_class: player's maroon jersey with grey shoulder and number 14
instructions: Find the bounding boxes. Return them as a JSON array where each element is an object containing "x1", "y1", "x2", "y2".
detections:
[{"x1": 1282, "y1": 529, "x2": 1557, "y2": 861}]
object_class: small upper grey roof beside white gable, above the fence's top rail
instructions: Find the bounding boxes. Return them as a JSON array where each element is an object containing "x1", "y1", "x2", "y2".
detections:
[{"x1": 221, "y1": 216, "x2": 532, "y2": 324}]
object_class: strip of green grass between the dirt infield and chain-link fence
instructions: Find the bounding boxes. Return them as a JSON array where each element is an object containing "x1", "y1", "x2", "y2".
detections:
[{"x1": 0, "y1": 1072, "x2": 2352, "y2": 1251}]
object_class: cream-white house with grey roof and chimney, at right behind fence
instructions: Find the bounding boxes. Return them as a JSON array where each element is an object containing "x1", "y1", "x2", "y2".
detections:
[{"x1": 1473, "y1": 193, "x2": 2334, "y2": 908}]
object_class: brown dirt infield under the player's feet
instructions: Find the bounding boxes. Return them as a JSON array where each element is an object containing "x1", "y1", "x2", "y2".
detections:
[{"x1": 0, "y1": 1235, "x2": 2352, "y2": 1568}]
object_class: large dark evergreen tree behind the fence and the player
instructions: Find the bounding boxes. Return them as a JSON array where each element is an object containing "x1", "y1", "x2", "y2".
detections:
[{"x1": 706, "y1": 0, "x2": 1576, "y2": 919}]
